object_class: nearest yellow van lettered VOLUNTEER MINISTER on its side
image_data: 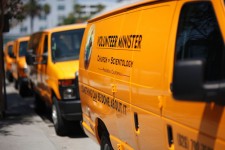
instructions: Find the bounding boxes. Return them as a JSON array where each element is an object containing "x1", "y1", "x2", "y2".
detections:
[{"x1": 79, "y1": 0, "x2": 225, "y2": 150}]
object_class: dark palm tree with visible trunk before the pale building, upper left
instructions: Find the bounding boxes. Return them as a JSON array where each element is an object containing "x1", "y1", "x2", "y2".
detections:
[{"x1": 24, "y1": 0, "x2": 51, "y2": 33}]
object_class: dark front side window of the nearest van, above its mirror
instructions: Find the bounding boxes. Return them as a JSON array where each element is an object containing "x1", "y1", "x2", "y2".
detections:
[{"x1": 175, "y1": 2, "x2": 224, "y2": 81}]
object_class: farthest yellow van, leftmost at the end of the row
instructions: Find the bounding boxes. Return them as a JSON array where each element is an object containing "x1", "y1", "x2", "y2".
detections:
[{"x1": 4, "y1": 41, "x2": 14, "y2": 82}]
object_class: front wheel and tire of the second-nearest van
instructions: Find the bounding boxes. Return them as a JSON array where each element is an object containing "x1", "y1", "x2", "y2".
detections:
[{"x1": 52, "y1": 96, "x2": 68, "y2": 136}]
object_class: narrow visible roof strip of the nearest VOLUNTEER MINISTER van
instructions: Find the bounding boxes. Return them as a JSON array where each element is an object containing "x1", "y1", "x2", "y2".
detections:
[{"x1": 88, "y1": 0, "x2": 172, "y2": 23}]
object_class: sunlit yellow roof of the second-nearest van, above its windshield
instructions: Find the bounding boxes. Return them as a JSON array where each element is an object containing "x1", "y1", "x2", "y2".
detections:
[{"x1": 43, "y1": 23, "x2": 86, "y2": 32}]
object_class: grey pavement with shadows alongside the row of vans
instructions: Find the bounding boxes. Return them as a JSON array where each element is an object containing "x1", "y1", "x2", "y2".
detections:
[{"x1": 0, "y1": 83, "x2": 100, "y2": 150}]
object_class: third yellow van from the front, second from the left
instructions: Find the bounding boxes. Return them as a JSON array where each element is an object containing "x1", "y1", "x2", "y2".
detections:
[{"x1": 12, "y1": 36, "x2": 30, "y2": 97}]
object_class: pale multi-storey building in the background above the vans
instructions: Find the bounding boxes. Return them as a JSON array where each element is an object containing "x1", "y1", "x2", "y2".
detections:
[{"x1": 4, "y1": 0, "x2": 138, "y2": 43}]
